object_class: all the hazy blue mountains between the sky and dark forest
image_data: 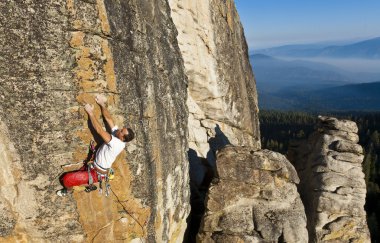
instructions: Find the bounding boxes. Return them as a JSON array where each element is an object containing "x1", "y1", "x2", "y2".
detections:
[{"x1": 250, "y1": 37, "x2": 380, "y2": 111}]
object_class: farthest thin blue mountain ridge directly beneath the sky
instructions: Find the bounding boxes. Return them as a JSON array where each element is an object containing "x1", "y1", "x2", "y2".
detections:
[{"x1": 255, "y1": 37, "x2": 380, "y2": 59}]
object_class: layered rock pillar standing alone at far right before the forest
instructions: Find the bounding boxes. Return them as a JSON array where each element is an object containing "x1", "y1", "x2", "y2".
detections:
[{"x1": 288, "y1": 116, "x2": 370, "y2": 242}]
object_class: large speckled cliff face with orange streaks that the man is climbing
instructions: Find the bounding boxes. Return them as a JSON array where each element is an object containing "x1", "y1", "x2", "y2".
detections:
[{"x1": 0, "y1": 0, "x2": 189, "y2": 242}]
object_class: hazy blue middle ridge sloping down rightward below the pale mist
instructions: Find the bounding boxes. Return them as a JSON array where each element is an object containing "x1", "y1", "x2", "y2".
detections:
[{"x1": 250, "y1": 54, "x2": 380, "y2": 93}]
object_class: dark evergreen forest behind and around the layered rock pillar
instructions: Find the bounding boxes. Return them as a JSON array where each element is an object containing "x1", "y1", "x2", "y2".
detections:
[{"x1": 260, "y1": 111, "x2": 380, "y2": 242}]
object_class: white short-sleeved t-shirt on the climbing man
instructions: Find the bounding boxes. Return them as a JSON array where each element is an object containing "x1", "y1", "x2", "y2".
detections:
[{"x1": 95, "y1": 126, "x2": 126, "y2": 169}]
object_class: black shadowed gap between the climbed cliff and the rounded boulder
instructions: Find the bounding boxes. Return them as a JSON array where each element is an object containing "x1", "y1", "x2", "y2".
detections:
[{"x1": 183, "y1": 124, "x2": 231, "y2": 243}]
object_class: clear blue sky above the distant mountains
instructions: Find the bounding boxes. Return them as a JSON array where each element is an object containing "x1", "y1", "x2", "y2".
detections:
[{"x1": 235, "y1": 0, "x2": 380, "y2": 50}]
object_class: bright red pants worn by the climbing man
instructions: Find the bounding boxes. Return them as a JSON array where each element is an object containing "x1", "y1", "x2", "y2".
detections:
[{"x1": 60, "y1": 165, "x2": 98, "y2": 188}]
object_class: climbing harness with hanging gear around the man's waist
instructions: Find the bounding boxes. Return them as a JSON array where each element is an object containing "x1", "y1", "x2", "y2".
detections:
[{"x1": 85, "y1": 140, "x2": 115, "y2": 197}]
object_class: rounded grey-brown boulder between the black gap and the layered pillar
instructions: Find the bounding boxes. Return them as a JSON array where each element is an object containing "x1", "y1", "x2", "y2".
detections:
[{"x1": 198, "y1": 146, "x2": 308, "y2": 242}]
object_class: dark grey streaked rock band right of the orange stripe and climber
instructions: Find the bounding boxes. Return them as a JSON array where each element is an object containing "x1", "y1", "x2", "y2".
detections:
[{"x1": 102, "y1": 0, "x2": 190, "y2": 242}]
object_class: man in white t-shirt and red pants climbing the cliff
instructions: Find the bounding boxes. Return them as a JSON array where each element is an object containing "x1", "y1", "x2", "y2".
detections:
[{"x1": 57, "y1": 95, "x2": 135, "y2": 197}]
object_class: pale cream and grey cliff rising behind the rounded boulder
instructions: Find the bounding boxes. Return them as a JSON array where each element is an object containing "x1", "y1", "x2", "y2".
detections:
[{"x1": 169, "y1": 0, "x2": 260, "y2": 166}]
